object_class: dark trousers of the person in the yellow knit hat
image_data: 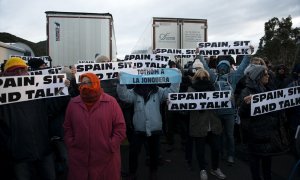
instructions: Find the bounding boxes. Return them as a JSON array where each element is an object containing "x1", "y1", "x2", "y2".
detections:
[{"x1": 14, "y1": 154, "x2": 55, "y2": 180}]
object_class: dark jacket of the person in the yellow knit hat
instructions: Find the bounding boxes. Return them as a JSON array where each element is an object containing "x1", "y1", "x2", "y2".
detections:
[{"x1": 0, "y1": 97, "x2": 69, "y2": 161}]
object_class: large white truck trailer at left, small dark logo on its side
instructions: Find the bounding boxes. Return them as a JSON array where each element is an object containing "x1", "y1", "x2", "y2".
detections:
[{"x1": 45, "y1": 11, "x2": 117, "y2": 66}]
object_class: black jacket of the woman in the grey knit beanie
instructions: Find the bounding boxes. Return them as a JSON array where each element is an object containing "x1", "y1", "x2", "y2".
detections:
[{"x1": 239, "y1": 79, "x2": 289, "y2": 156}]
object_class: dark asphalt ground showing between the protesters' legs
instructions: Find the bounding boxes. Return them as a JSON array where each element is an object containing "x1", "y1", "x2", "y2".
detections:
[{"x1": 121, "y1": 136, "x2": 300, "y2": 180}]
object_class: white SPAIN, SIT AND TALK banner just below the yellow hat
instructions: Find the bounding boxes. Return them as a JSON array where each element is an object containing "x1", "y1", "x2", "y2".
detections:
[{"x1": 0, "y1": 74, "x2": 69, "y2": 105}]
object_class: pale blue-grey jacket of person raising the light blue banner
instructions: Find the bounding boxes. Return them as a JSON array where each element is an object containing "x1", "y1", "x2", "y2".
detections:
[{"x1": 117, "y1": 84, "x2": 180, "y2": 136}]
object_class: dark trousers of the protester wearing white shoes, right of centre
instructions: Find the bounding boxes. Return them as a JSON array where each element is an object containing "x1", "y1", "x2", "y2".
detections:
[{"x1": 194, "y1": 132, "x2": 221, "y2": 170}]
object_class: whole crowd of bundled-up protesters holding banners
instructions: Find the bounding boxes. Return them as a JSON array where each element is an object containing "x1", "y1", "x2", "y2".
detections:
[{"x1": 0, "y1": 50, "x2": 300, "y2": 180}]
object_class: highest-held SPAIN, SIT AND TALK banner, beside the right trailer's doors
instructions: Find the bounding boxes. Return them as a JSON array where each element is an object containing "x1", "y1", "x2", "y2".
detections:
[{"x1": 197, "y1": 41, "x2": 251, "y2": 56}]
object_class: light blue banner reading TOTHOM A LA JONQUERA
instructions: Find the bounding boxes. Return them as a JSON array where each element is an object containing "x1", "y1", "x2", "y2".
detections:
[{"x1": 120, "y1": 68, "x2": 181, "y2": 84}]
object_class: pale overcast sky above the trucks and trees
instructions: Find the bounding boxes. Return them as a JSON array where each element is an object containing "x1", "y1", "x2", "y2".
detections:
[{"x1": 0, "y1": 0, "x2": 300, "y2": 58}]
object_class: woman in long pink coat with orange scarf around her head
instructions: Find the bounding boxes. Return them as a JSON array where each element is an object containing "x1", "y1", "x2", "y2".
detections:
[{"x1": 64, "y1": 73, "x2": 126, "y2": 180}]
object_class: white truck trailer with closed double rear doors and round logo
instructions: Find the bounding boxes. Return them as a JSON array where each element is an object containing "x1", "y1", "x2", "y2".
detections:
[{"x1": 131, "y1": 17, "x2": 207, "y2": 63}]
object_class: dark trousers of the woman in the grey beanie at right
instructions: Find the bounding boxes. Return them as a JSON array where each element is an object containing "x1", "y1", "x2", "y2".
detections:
[{"x1": 249, "y1": 155, "x2": 272, "y2": 180}]
